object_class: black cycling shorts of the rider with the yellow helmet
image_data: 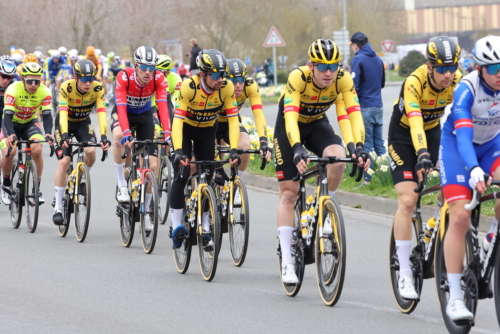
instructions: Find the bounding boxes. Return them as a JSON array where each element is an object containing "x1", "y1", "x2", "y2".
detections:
[{"x1": 274, "y1": 99, "x2": 342, "y2": 182}]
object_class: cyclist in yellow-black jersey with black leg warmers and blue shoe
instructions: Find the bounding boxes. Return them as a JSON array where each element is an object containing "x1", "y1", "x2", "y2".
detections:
[{"x1": 170, "y1": 49, "x2": 241, "y2": 247}]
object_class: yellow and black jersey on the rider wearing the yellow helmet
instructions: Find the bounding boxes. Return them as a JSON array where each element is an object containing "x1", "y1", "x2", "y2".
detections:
[{"x1": 281, "y1": 66, "x2": 365, "y2": 147}]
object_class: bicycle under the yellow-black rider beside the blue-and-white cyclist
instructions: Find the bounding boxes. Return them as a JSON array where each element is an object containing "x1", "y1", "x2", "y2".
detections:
[{"x1": 389, "y1": 169, "x2": 441, "y2": 314}]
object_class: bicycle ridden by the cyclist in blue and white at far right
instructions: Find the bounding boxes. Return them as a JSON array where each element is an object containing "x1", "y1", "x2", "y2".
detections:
[{"x1": 434, "y1": 181, "x2": 500, "y2": 333}]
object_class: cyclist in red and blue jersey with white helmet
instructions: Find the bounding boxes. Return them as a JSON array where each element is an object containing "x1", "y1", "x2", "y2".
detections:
[{"x1": 111, "y1": 46, "x2": 170, "y2": 230}]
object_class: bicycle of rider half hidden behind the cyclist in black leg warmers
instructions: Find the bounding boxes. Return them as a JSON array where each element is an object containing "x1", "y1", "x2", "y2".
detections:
[{"x1": 216, "y1": 146, "x2": 267, "y2": 267}]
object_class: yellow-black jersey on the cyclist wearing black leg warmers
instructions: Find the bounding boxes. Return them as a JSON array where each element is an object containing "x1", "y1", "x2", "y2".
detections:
[{"x1": 172, "y1": 75, "x2": 240, "y2": 149}]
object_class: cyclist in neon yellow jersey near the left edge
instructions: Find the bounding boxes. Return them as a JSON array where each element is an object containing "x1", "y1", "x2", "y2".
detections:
[{"x1": 0, "y1": 63, "x2": 53, "y2": 205}]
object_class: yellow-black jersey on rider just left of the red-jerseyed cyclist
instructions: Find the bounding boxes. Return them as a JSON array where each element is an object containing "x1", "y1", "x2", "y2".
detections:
[{"x1": 59, "y1": 79, "x2": 108, "y2": 136}]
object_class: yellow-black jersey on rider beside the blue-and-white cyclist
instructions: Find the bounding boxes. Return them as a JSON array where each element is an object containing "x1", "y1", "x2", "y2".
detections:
[{"x1": 391, "y1": 64, "x2": 462, "y2": 152}]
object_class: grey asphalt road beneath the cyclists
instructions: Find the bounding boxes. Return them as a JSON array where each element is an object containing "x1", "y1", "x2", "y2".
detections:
[{"x1": 0, "y1": 109, "x2": 499, "y2": 334}]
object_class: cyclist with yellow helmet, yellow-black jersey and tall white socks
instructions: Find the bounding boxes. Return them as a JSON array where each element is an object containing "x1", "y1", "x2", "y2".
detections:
[{"x1": 274, "y1": 39, "x2": 370, "y2": 284}]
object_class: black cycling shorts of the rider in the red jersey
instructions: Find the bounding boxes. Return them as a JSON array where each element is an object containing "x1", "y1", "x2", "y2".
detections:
[{"x1": 111, "y1": 105, "x2": 158, "y2": 157}]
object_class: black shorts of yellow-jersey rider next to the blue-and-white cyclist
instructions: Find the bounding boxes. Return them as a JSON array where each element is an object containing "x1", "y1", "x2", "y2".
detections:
[{"x1": 388, "y1": 121, "x2": 441, "y2": 184}]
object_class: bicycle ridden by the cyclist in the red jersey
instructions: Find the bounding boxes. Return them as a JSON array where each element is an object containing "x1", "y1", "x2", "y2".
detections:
[{"x1": 116, "y1": 139, "x2": 163, "y2": 254}]
